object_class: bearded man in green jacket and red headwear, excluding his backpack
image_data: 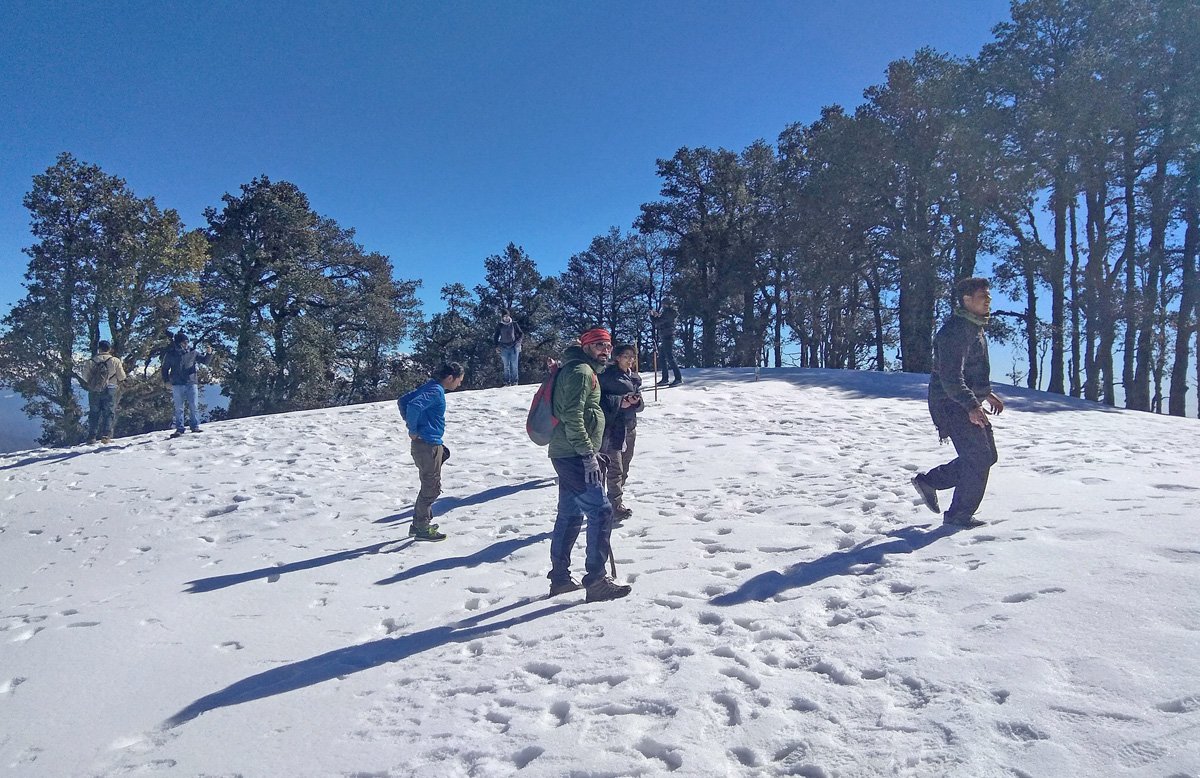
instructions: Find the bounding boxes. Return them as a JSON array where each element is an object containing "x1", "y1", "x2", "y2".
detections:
[{"x1": 546, "y1": 328, "x2": 632, "y2": 603}]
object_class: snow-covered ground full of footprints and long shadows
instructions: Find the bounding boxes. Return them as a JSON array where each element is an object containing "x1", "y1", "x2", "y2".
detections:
[{"x1": 0, "y1": 370, "x2": 1200, "y2": 778}]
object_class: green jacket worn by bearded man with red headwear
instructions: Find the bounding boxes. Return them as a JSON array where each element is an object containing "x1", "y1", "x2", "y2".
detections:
[{"x1": 550, "y1": 346, "x2": 604, "y2": 459}]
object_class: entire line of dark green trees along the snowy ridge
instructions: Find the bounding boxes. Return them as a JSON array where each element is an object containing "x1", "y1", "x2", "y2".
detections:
[{"x1": 0, "y1": 0, "x2": 1200, "y2": 444}]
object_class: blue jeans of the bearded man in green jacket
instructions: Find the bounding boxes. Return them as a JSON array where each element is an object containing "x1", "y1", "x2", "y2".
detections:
[{"x1": 546, "y1": 456, "x2": 612, "y2": 586}]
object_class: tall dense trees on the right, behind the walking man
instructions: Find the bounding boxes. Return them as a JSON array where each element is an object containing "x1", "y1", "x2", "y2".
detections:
[{"x1": 637, "y1": 0, "x2": 1200, "y2": 415}]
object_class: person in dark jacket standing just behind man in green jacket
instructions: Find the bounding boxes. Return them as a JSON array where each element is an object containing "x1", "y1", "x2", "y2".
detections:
[{"x1": 600, "y1": 346, "x2": 646, "y2": 521}]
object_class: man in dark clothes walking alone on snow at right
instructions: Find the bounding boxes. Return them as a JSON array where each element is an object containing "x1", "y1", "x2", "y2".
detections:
[{"x1": 912, "y1": 277, "x2": 1004, "y2": 527}]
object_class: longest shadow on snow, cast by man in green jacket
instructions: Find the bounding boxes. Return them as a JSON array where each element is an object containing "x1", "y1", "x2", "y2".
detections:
[{"x1": 162, "y1": 597, "x2": 583, "y2": 729}]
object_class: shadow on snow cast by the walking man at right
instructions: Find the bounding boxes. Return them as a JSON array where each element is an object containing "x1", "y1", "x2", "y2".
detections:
[{"x1": 709, "y1": 525, "x2": 959, "y2": 605}]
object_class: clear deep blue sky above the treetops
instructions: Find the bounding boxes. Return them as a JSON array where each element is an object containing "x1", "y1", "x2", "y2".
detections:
[{"x1": 0, "y1": 0, "x2": 1008, "y2": 315}]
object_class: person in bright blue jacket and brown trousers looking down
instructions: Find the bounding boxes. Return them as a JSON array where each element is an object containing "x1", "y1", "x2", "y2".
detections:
[{"x1": 396, "y1": 361, "x2": 466, "y2": 540}]
